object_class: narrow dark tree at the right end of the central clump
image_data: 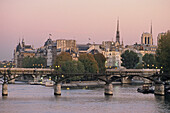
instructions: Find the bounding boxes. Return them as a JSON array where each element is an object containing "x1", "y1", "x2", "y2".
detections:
[{"x1": 94, "y1": 53, "x2": 106, "y2": 73}]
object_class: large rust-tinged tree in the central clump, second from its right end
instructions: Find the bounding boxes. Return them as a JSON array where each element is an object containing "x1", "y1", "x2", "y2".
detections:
[{"x1": 79, "y1": 54, "x2": 99, "y2": 73}]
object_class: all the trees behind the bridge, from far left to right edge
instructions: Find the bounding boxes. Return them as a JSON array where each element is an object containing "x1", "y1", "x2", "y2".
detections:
[{"x1": 22, "y1": 33, "x2": 170, "y2": 73}]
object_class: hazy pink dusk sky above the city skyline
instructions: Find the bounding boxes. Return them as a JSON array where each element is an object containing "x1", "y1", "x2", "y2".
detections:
[{"x1": 0, "y1": 0, "x2": 170, "y2": 60}]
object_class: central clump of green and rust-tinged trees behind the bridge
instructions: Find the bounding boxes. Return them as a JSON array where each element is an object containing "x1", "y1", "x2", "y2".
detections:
[{"x1": 54, "y1": 52, "x2": 106, "y2": 73}]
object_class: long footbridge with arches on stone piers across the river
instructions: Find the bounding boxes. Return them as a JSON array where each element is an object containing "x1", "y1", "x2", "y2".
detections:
[{"x1": 0, "y1": 68, "x2": 165, "y2": 96}]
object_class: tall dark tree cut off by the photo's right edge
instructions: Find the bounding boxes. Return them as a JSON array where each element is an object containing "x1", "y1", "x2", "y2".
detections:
[{"x1": 156, "y1": 32, "x2": 170, "y2": 74}]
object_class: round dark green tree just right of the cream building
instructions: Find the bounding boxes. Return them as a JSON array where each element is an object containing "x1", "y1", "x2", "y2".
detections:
[{"x1": 121, "y1": 50, "x2": 139, "y2": 69}]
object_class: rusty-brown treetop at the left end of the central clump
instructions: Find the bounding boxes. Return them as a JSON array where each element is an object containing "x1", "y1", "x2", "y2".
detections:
[{"x1": 54, "y1": 52, "x2": 72, "y2": 67}]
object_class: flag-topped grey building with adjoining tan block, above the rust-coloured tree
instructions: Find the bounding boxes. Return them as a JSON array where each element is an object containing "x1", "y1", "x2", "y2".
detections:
[{"x1": 36, "y1": 35, "x2": 77, "y2": 67}]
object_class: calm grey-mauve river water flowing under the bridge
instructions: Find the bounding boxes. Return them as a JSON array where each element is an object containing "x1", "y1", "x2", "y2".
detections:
[{"x1": 0, "y1": 84, "x2": 170, "y2": 113}]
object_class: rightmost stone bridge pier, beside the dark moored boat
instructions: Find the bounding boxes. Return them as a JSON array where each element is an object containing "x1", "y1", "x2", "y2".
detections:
[{"x1": 154, "y1": 84, "x2": 165, "y2": 95}]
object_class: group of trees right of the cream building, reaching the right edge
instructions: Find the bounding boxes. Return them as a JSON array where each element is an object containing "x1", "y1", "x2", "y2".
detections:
[{"x1": 121, "y1": 32, "x2": 170, "y2": 74}]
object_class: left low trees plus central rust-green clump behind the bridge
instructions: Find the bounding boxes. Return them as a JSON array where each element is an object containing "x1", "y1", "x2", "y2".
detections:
[{"x1": 22, "y1": 52, "x2": 106, "y2": 73}]
